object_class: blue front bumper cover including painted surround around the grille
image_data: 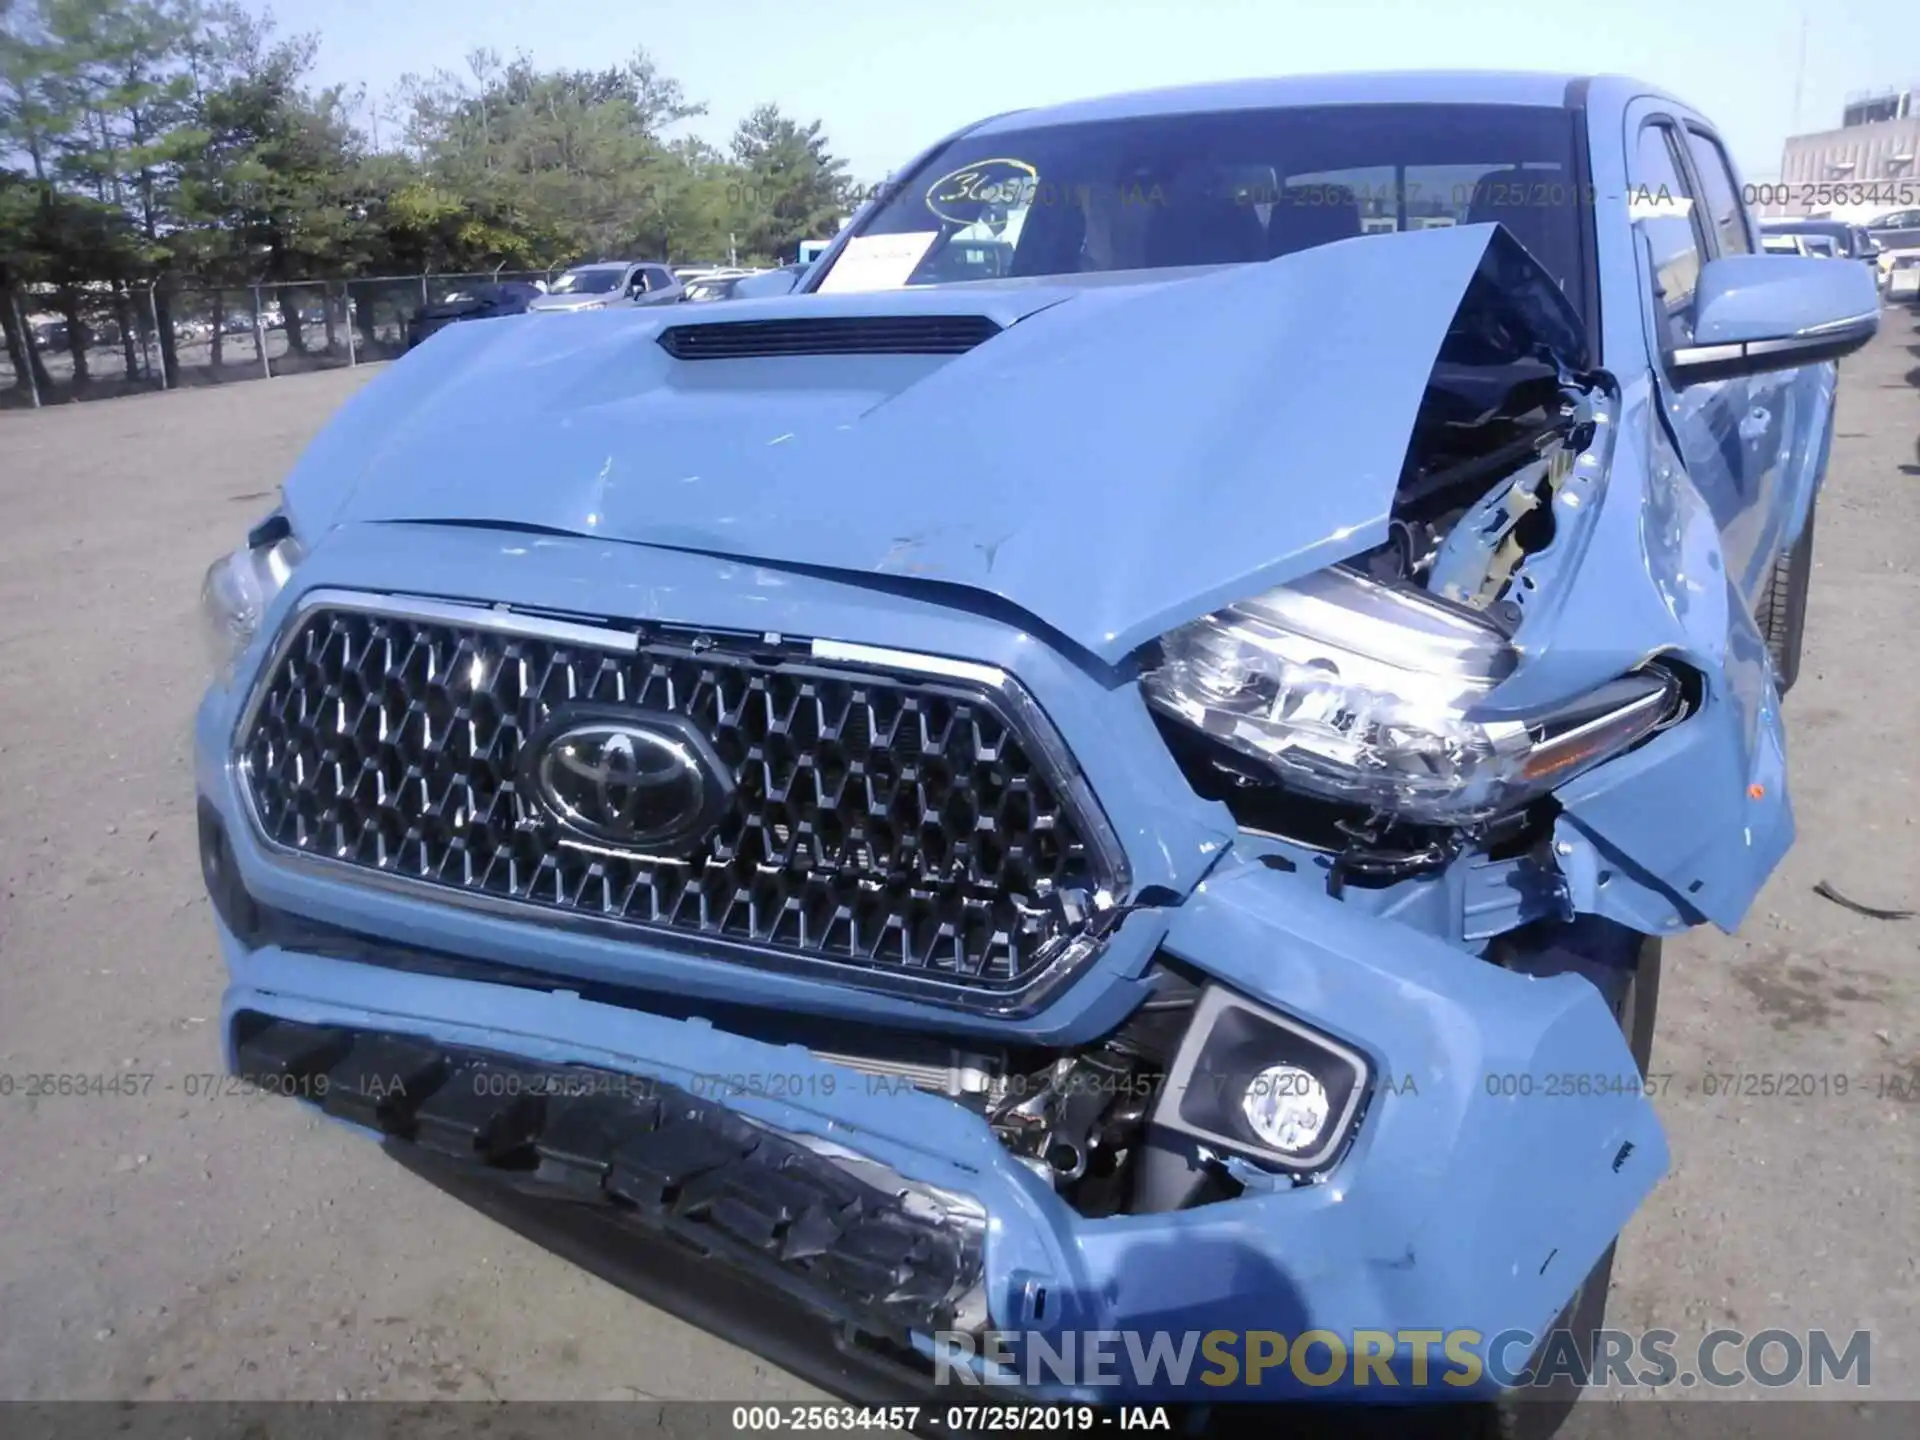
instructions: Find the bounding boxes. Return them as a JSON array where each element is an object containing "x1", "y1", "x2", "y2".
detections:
[{"x1": 196, "y1": 526, "x2": 1667, "y2": 1402}]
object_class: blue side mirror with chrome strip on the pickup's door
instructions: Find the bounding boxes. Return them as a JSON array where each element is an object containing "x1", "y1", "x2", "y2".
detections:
[{"x1": 1667, "y1": 253, "x2": 1880, "y2": 386}]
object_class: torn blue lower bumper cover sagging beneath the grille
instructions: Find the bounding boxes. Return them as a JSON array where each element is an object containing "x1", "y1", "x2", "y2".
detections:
[{"x1": 223, "y1": 898, "x2": 1667, "y2": 1402}]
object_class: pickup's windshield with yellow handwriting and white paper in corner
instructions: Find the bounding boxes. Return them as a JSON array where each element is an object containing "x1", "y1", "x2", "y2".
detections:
[{"x1": 816, "y1": 106, "x2": 1584, "y2": 320}]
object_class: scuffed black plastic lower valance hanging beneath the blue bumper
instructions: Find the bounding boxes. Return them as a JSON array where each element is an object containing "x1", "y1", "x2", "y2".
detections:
[{"x1": 234, "y1": 1014, "x2": 985, "y2": 1356}]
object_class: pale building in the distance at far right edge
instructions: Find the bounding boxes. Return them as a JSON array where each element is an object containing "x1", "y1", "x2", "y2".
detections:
[{"x1": 1749, "y1": 86, "x2": 1920, "y2": 223}]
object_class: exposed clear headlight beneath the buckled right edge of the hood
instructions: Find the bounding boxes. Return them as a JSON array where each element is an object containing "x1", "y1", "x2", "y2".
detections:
[{"x1": 1142, "y1": 566, "x2": 1680, "y2": 826}]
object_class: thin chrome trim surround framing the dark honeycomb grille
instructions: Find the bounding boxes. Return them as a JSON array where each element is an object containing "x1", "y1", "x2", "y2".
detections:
[{"x1": 227, "y1": 589, "x2": 1133, "y2": 1018}]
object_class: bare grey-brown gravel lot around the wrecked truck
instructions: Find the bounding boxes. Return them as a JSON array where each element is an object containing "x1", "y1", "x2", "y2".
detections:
[{"x1": 0, "y1": 311, "x2": 1920, "y2": 1400}]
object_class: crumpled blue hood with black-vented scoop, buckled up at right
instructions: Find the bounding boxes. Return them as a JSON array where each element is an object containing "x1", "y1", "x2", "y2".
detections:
[{"x1": 286, "y1": 225, "x2": 1582, "y2": 660}]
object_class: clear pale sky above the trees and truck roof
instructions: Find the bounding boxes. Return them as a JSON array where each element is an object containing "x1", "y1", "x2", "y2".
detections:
[{"x1": 278, "y1": 0, "x2": 1896, "y2": 180}]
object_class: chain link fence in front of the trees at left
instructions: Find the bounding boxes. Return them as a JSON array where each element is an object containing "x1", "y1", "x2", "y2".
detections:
[{"x1": 0, "y1": 267, "x2": 561, "y2": 409}]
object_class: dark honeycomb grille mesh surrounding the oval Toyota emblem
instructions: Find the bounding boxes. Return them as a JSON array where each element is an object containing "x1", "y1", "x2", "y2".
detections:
[{"x1": 236, "y1": 591, "x2": 1125, "y2": 1008}]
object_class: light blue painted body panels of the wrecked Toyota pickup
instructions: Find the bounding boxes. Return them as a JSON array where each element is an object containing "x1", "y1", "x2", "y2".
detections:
[{"x1": 196, "y1": 73, "x2": 1836, "y2": 1400}]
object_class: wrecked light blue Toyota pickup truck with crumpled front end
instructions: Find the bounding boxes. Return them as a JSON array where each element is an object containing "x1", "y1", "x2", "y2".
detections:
[{"x1": 196, "y1": 75, "x2": 1878, "y2": 1428}]
